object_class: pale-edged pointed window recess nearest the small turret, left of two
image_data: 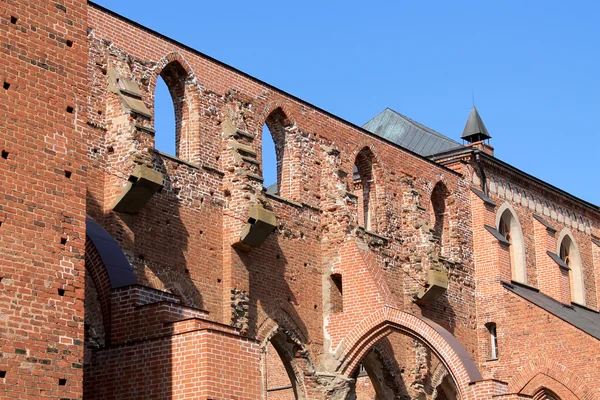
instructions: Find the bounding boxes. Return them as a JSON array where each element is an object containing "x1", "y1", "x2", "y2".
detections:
[{"x1": 496, "y1": 203, "x2": 527, "y2": 283}]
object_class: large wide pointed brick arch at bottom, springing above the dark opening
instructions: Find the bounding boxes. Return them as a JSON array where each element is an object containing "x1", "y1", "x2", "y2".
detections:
[{"x1": 337, "y1": 307, "x2": 483, "y2": 399}]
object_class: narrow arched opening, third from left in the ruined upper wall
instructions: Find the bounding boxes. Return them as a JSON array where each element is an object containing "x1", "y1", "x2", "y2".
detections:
[{"x1": 353, "y1": 147, "x2": 377, "y2": 232}]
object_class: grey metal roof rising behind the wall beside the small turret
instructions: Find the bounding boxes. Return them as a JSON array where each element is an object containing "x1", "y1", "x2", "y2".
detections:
[{"x1": 363, "y1": 108, "x2": 462, "y2": 157}]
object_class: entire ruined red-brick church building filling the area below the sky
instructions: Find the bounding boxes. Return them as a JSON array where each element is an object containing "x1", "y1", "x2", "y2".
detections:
[{"x1": 0, "y1": 0, "x2": 600, "y2": 400}]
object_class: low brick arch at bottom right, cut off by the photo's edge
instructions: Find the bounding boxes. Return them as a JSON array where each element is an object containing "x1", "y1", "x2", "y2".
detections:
[{"x1": 508, "y1": 357, "x2": 597, "y2": 400}]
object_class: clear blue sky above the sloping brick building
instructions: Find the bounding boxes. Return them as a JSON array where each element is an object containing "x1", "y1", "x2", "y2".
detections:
[{"x1": 97, "y1": 0, "x2": 600, "y2": 204}]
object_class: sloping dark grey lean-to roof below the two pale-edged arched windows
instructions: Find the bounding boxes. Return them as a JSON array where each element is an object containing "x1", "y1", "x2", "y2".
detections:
[{"x1": 502, "y1": 282, "x2": 600, "y2": 339}]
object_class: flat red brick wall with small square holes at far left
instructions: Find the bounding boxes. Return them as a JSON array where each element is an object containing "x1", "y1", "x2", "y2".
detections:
[{"x1": 0, "y1": 0, "x2": 88, "y2": 399}]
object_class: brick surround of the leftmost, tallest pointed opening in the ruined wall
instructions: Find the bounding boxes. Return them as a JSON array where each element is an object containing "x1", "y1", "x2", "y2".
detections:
[{"x1": 153, "y1": 53, "x2": 201, "y2": 162}]
